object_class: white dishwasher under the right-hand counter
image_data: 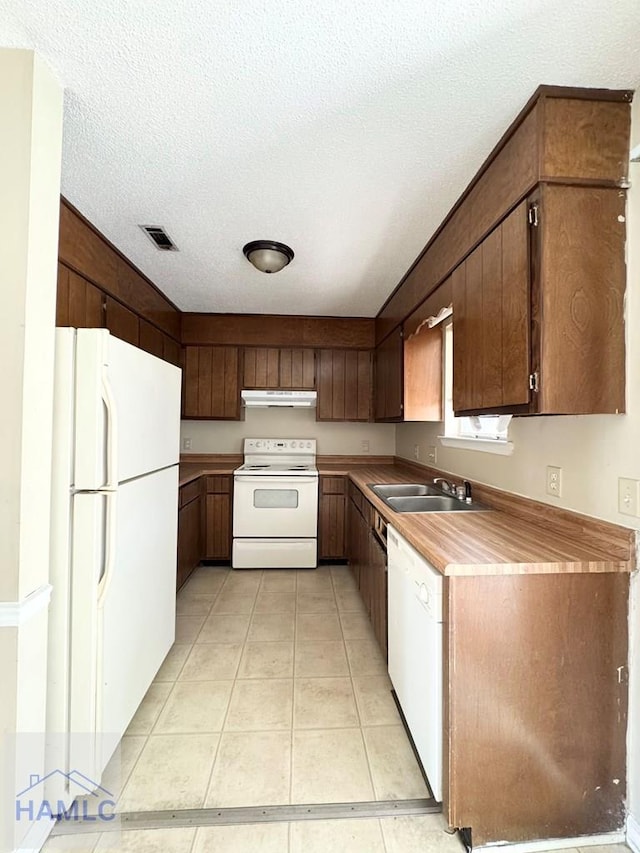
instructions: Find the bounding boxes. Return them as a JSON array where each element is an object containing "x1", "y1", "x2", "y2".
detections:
[{"x1": 387, "y1": 525, "x2": 443, "y2": 802}]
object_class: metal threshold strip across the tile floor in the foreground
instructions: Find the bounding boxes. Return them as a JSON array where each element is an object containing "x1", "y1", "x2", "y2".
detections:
[{"x1": 51, "y1": 798, "x2": 442, "y2": 837}]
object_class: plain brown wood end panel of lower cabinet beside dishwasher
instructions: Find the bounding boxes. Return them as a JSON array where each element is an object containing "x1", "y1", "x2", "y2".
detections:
[{"x1": 443, "y1": 572, "x2": 629, "y2": 847}]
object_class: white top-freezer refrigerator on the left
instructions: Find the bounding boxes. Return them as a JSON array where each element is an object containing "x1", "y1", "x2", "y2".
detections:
[{"x1": 47, "y1": 328, "x2": 181, "y2": 804}]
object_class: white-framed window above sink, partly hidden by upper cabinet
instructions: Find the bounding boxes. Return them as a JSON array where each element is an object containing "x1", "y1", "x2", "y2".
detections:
[{"x1": 438, "y1": 319, "x2": 513, "y2": 455}]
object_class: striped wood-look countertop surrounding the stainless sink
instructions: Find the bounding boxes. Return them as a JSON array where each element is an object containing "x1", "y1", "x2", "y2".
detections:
[{"x1": 349, "y1": 465, "x2": 633, "y2": 576}]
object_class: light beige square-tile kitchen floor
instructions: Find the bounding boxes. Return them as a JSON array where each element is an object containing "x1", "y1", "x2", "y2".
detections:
[{"x1": 45, "y1": 566, "x2": 626, "y2": 853}]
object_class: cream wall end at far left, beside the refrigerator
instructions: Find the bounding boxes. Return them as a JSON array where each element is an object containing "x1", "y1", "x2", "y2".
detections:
[{"x1": 0, "y1": 50, "x2": 62, "y2": 853}]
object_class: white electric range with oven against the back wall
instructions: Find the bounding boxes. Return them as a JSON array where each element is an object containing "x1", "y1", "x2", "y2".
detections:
[{"x1": 231, "y1": 438, "x2": 318, "y2": 569}]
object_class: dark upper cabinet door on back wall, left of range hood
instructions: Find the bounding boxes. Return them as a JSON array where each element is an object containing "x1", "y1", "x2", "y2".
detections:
[{"x1": 183, "y1": 346, "x2": 240, "y2": 420}]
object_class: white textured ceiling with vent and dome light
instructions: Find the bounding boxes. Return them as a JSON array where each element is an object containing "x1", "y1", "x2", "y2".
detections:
[{"x1": 0, "y1": 0, "x2": 640, "y2": 316}]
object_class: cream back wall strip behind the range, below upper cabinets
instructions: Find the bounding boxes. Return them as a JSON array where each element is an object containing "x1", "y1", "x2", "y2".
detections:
[{"x1": 181, "y1": 408, "x2": 396, "y2": 456}]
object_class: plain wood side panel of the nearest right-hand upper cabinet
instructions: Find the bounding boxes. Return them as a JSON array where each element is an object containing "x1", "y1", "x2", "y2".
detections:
[{"x1": 532, "y1": 184, "x2": 627, "y2": 414}]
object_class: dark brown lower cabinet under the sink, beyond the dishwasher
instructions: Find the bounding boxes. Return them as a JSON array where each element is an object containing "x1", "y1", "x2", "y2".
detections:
[{"x1": 348, "y1": 484, "x2": 387, "y2": 658}]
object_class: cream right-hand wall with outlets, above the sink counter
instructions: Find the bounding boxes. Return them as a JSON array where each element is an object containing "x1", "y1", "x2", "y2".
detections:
[{"x1": 397, "y1": 96, "x2": 640, "y2": 822}]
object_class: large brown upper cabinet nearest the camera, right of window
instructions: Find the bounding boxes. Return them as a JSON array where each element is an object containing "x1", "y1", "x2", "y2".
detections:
[{"x1": 452, "y1": 184, "x2": 625, "y2": 414}]
